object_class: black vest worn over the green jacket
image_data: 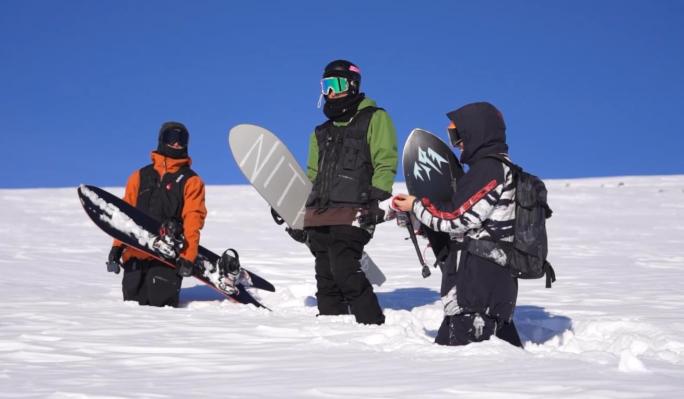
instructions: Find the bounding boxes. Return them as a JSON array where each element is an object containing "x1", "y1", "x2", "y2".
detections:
[{"x1": 306, "y1": 107, "x2": 382, "y2": 209}]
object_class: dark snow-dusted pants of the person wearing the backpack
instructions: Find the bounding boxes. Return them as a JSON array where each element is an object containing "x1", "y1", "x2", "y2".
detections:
[{"x1": 435, "y1": 243, "x2": 522, "y2": 347}]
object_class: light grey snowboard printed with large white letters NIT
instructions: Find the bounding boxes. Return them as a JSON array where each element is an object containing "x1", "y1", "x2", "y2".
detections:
[{"x1": 228, "y1": 124, "x2": 386, "y2": 286}]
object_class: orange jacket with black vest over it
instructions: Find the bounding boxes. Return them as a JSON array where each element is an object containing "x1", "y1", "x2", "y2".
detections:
[{"x1": 114, "y1": 151, "x2": 207, "y2": 262}]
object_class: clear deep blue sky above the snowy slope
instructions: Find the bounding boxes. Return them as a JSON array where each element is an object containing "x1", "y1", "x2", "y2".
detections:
[{"x1": 0, "y1": 0, "x2": 684, "y2": 187}]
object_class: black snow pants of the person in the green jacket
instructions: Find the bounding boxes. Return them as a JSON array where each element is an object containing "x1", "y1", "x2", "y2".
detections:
[{"x1": 307, "y1": 225, "x2": 385, "y2": 324}]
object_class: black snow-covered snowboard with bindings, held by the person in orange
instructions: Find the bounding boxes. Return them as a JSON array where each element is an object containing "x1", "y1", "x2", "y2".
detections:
[{"x1": 78, "y1": 185, "x2": 275, "y2": 308}]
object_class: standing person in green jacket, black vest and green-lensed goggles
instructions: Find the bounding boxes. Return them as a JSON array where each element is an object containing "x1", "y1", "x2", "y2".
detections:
[{"x1": 291, "y1": 60, "x2": 398, "y2": 324}]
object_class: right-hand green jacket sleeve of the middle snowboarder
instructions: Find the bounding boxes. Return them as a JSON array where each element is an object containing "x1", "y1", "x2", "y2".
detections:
[{"x1": 367, "y1": 110, "x2": 398, "y2": 194}]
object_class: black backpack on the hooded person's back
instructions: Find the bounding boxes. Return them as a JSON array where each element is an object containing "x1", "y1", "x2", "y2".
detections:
[{"x1": 468, "y1": 155, "x2": 556, "y2": 288}]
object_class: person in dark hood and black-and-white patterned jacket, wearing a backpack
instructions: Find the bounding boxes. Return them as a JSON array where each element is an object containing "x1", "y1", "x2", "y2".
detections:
[{"x1": 392, "y1": 102, "x2": 522, "y2": 346}]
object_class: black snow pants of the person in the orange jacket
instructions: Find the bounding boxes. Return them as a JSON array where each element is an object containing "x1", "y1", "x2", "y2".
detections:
[{"x1": 121, "y1": 258, "x2": 183, "y2": 307}]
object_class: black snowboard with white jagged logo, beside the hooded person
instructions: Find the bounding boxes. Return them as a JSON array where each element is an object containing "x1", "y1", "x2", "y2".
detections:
[{"x1": 402, "y1": 129, "x2": 463, "y2": 259}]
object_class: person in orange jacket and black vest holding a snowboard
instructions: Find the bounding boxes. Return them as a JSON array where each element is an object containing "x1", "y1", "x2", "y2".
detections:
[{"x1": 107, "y1": 122, "x2": 207, "y2": 307}]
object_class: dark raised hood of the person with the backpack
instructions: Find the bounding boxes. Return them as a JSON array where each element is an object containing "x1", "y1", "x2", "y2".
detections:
[{"x1": 447, "y1": 102, "x2": 508, "y2": 164}]
